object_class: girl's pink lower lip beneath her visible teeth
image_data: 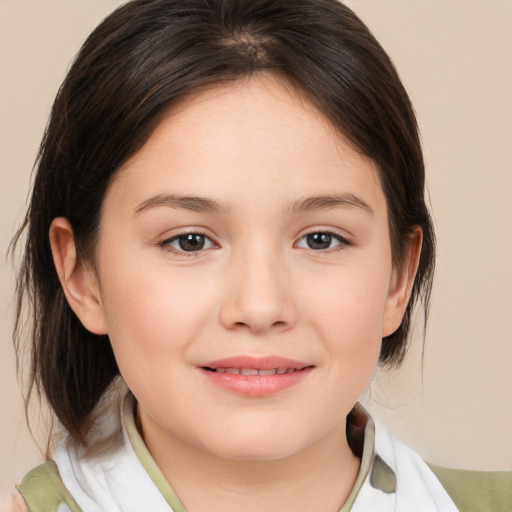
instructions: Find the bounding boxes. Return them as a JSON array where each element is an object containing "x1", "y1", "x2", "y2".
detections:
[{"x1": 201, "y1": 367, "x2": 313, "y2": 397}]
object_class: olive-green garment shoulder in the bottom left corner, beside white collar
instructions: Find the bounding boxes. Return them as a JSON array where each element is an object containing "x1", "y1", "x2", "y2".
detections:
[{"x1": 13, "y1": 460, "x2": 81, "y2": 512}]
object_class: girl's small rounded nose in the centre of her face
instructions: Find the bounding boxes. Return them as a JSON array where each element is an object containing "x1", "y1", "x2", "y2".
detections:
[{"x1": 220, "y1": 246, "x2": 297, "y2": 334}]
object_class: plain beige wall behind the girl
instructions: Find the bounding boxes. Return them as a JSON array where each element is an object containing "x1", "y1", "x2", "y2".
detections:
[{"x1": 0, "y1": 0, "x2": 512, "y2": 504}]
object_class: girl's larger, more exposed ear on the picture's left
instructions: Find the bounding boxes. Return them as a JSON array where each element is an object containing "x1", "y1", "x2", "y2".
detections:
[{"x1": 50, "y1": 217, "x2": 107, "y2": 334}]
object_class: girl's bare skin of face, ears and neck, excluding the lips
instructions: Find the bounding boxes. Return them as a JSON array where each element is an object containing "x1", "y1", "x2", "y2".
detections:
[{"x1": 50, "y1": 75, "x2": 421, "y2": 512}]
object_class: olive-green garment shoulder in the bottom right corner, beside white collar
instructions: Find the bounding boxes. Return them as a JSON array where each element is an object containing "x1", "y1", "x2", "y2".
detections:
[{"x1": 429, "y1": 464, "x2": 512, "y2": 512}]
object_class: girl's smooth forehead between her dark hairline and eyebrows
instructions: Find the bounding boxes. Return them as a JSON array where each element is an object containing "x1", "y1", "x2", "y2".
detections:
[{"x1": 106, "y1": 75, "x2": 380, "y2": 212}]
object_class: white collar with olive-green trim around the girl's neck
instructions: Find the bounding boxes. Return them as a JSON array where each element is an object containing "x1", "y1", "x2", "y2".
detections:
[{"x1": 53, "y1": 393, "x2": 457, "y2": 512}]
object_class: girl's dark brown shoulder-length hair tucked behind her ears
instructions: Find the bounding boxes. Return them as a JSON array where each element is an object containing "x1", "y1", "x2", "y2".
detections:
[{"x1": 15, "y1": 0, "x2": 434, "y2": 442}]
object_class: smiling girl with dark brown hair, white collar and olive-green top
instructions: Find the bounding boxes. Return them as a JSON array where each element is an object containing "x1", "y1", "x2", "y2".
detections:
[{"x1": 9, "y1": 0, "x2": 510, "y2": 512}]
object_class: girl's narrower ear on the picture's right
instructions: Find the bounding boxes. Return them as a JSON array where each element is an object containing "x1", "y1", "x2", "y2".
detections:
[{"x1": 382, "y1": 226, "x2": 423, "y2": 338}]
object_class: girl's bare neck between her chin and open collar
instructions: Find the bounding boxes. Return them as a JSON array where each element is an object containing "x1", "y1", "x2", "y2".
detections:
[{"x1": 140, "y1": 418, "x2": 360, "y2": 512}]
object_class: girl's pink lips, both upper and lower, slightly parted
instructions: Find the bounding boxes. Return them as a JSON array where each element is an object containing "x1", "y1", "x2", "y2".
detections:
[{"x1": 199, "y1": 356, "x2": 314, "y2": 397}]
